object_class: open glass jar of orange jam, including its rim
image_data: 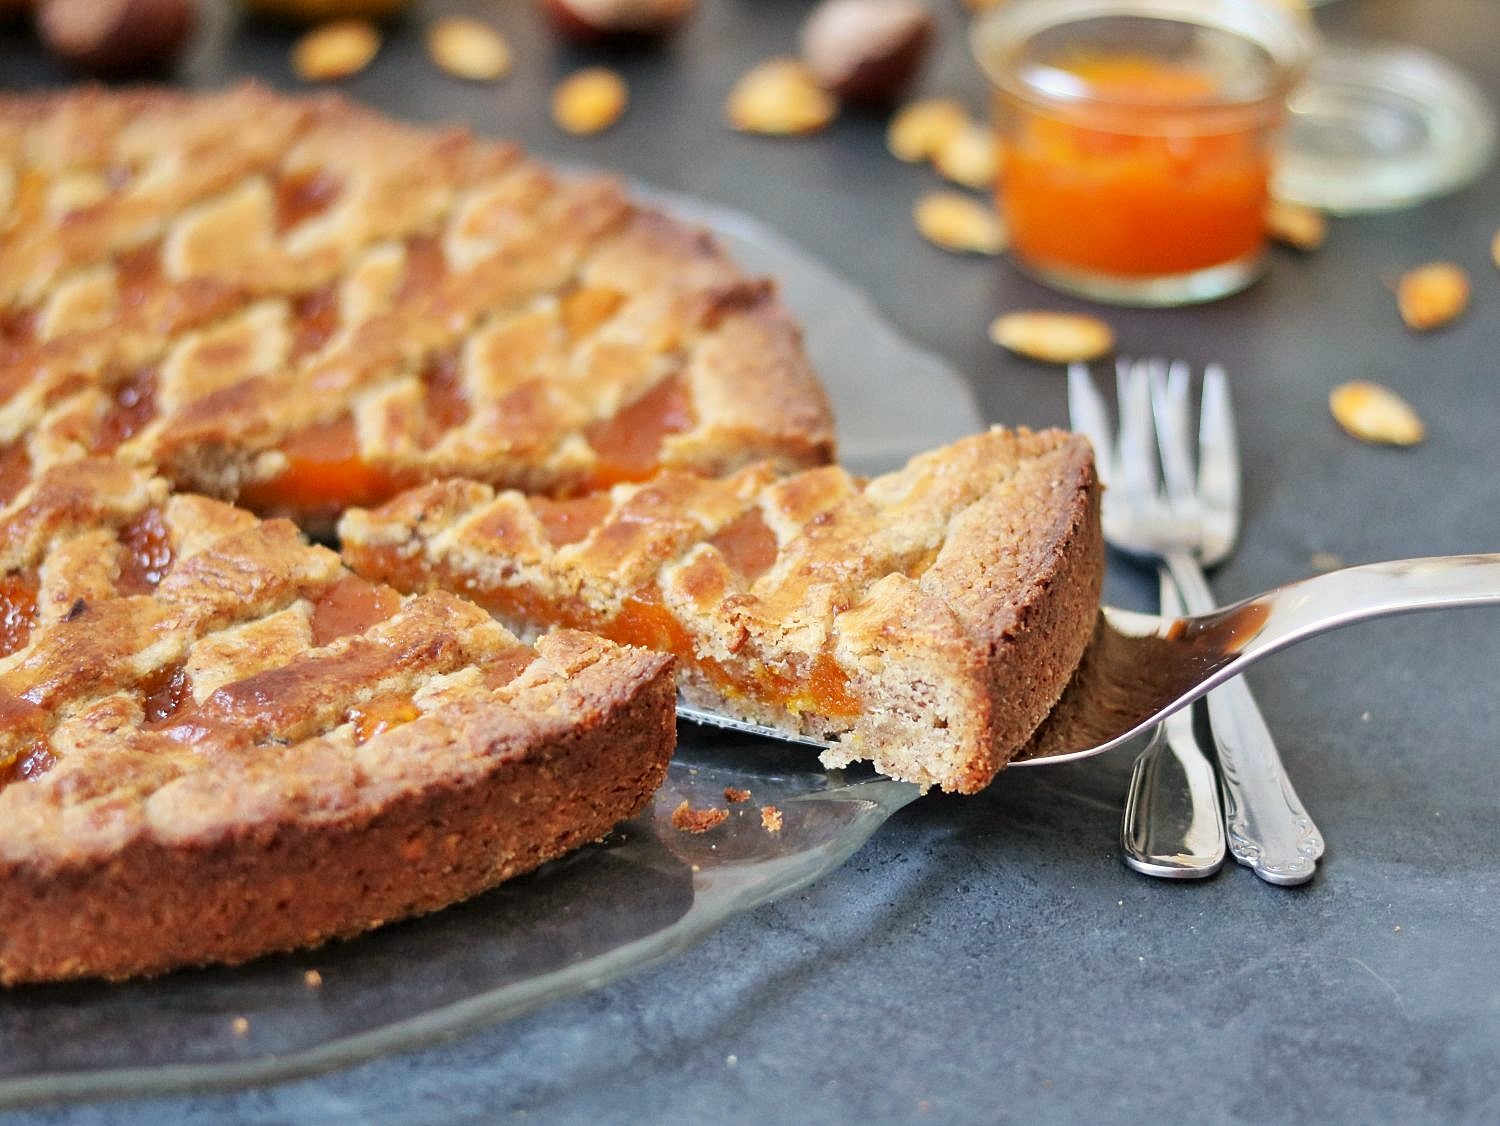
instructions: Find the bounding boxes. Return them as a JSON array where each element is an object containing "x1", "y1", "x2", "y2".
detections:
[{"x1": 974, "y1": 0, "x2": 1314, "y2": 306}]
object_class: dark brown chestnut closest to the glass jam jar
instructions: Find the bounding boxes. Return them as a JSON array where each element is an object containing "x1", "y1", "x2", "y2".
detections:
[{"x1": 801, "y1": 0, "x2": 933, "y2": 106}]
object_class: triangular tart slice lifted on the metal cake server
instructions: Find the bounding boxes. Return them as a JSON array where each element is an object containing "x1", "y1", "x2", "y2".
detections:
[{"x1": 339, "y1": 430, "x2": 1103, "y2": 793}]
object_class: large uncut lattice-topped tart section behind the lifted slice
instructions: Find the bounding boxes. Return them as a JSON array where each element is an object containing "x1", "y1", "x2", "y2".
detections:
[{"x1": 0, "y1": 85, "x2": 833, "y2": 531}]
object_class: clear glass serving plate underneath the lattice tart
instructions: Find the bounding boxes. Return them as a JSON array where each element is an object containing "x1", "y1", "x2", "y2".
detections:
[{"x1": 0, "y1": 189, "x2": 983, "y2": 1107}]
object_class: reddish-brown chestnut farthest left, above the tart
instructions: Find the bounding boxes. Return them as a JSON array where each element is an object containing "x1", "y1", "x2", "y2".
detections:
[{"x1": 36, "y1": 0, "x2": 198, "y2": 78}]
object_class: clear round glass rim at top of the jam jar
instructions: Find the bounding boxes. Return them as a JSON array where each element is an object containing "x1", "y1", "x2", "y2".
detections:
[{"x1": 969, "y1": 0, "x2": 1317, "y2": 111}]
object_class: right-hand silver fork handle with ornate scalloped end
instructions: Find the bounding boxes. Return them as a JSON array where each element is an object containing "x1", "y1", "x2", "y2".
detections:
[{"x1": 1166, "y1": 552, "x2": 1323, "y2": 885}]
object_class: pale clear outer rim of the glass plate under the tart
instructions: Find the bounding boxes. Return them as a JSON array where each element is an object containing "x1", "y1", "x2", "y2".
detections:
[{"x1": 0, "y1": 181, "x2": 984, "y2": 1108}]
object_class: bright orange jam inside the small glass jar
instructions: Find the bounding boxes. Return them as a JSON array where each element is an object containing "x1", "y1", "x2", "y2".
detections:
[{"x1": 998, "y1": 57, "x2": 1271, "y2": 277}]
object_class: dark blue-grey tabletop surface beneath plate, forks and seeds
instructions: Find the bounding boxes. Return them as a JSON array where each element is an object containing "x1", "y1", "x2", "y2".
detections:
[{"x1": 0, "y1": 0, "x2": 1500, "y2": 1125}]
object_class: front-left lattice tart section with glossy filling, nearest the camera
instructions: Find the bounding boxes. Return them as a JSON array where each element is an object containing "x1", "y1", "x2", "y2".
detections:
[{"x1": 0, "y1": 460, "x2": 675, "y2": 984}]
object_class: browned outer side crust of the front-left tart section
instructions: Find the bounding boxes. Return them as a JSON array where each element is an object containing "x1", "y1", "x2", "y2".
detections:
[{"x1": 0, "y1": 650, "x2": 674, "y2": 985}]
